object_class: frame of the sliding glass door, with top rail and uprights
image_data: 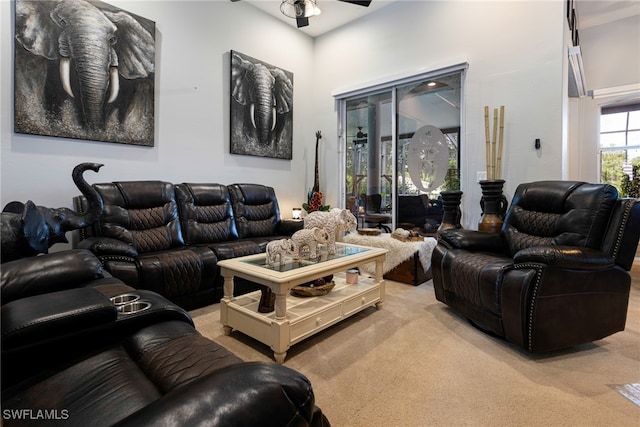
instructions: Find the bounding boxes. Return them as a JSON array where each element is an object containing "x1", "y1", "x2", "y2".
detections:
[{"x1": 332, "y1": 62, "x2": 469, "y2": 229}]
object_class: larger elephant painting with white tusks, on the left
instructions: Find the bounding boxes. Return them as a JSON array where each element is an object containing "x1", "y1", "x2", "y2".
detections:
[{"x1": 15, "y1": 0, "x2": 155, "y2": 146}]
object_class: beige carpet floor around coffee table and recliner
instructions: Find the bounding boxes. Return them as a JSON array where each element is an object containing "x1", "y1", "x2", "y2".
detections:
[{"x1": 191, "y1": 258, "x2": 640, "y2": 427}]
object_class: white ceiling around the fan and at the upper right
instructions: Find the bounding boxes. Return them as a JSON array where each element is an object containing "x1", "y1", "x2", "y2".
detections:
[{"x1": 243, "y1": 0, "x2": 640, "y2": 37}]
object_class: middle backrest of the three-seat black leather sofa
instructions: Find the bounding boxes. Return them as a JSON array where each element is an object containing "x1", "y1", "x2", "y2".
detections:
[{"x1": 175, "y1": 183, "x2": 238, "y2": 245}]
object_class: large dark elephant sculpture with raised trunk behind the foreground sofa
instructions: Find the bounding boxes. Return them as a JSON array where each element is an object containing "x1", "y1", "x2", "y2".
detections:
[{"x1": 0, "y1": 163, "x2": 104, "y2": 262}]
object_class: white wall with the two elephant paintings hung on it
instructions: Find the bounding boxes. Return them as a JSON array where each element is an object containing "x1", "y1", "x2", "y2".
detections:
[{"x1": 0, "y1": 0, "x2": 315, "y2": 217}]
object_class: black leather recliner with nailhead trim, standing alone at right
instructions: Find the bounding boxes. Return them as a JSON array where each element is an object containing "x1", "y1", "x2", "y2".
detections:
[{"x1": 431, "y1": 181, "x2": 640, "y2": 353}]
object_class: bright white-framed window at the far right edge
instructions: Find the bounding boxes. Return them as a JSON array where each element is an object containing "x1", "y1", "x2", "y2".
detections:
[{"x1": 600, "y1": 103, "x2": 640, "y2": 197}]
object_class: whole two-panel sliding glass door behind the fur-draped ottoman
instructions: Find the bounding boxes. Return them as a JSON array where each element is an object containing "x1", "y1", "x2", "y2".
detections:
[{"x1": 339, "y1": 68, "x2": 464, "y2": 234}]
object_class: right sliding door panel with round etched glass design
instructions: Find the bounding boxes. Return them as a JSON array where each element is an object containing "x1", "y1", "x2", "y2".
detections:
[{"x1": 394, "y1": 73, "x2": 460, "y2": 234}]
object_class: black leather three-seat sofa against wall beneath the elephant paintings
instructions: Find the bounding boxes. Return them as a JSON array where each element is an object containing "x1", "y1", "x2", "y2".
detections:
[{"x1": 74, "y1": 181, "x2": 303, "y2": 309}]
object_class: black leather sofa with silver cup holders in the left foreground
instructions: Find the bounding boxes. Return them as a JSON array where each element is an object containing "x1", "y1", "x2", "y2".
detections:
[{"x1": 0, "y1": 250, "x2": 329, "y2": 427}]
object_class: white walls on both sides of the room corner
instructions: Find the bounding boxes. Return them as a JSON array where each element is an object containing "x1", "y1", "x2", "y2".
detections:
[{"x1": 5, "y1": 0, "x2": 624, "y2": 236}]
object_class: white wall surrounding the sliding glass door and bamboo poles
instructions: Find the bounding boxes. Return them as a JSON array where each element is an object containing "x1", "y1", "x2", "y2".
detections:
[{"x1": 314, "y1": 1, "x2": 566, "y2": 228}]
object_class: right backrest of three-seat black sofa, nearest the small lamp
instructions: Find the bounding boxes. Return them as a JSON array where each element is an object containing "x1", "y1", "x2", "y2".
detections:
[{"x1": 228, "y1": 184, "x2": 280, "y2": 238}]
